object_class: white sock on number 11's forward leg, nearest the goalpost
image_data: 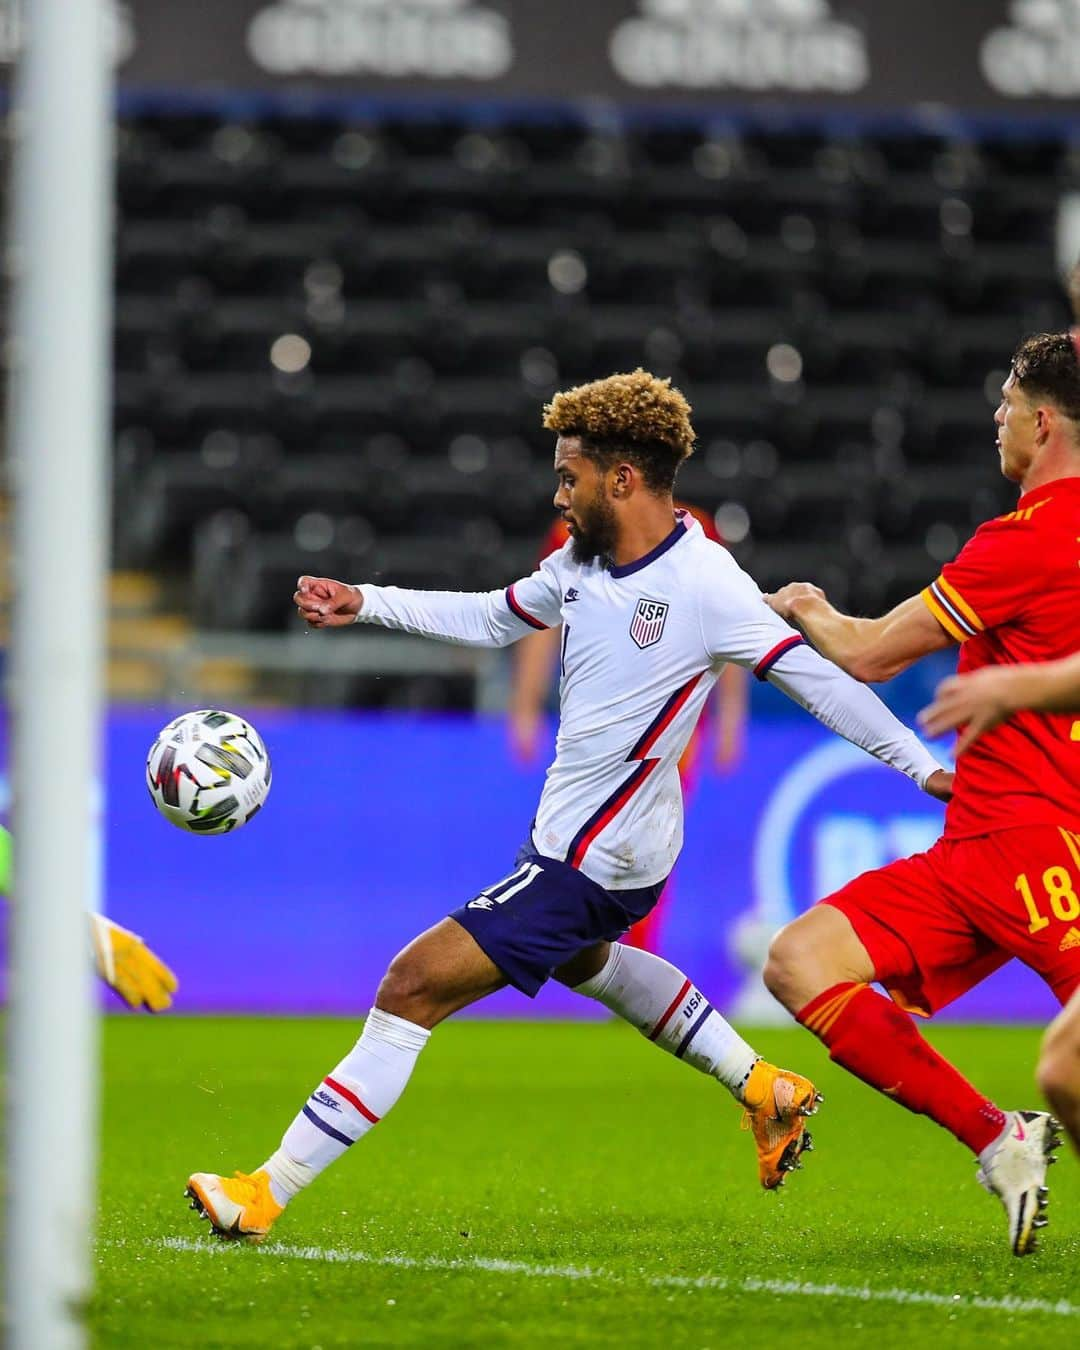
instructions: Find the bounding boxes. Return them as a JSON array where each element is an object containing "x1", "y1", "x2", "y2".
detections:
[{"x1": 263, "y1": 1008, "x2": 431, "y2": 1204}]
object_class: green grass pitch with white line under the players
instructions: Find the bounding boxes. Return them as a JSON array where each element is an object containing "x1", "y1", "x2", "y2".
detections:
[{"x1": 90, "y1": 1017, "x2": 1080, "y2": 1350}]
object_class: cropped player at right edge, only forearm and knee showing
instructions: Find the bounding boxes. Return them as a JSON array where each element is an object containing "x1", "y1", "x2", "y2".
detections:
[{"x1": 919, "y1": 652, "x2": 1080, "y2": 1153}]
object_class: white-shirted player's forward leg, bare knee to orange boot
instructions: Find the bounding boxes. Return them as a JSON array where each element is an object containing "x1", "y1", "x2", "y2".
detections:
[{"x1": 188, "y1": 918, "x2": 506, "y2": 1242}]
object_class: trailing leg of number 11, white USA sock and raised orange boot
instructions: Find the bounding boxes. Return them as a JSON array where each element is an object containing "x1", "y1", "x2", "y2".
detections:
[{"x1": 555, "y1": 941, "x2": 819, "y2": 1191}]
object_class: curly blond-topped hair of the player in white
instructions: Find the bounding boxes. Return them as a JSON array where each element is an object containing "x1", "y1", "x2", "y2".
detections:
[{"x1": 544, "y1": 366, "x2": 694, "y2": 491}]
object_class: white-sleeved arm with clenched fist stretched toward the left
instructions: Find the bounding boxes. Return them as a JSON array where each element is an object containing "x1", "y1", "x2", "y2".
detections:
[{"x1": 293, "y1": 564, "x2": 559, "y2": 647}]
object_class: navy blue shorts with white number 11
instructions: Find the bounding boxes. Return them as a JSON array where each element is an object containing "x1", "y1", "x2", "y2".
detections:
[{"x1": 450, "y1": 844, "x2": 667, "y2": 998}]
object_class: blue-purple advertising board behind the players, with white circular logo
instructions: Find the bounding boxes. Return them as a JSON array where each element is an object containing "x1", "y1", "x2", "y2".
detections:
[{"x1": 0, "y1": 709, "x2": 1056, "y2": 1021}]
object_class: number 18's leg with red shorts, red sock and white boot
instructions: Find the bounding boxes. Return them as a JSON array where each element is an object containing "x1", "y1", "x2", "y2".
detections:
[{"x1": 765, "y1": 841, "x2": 1058, "y2": 1256}]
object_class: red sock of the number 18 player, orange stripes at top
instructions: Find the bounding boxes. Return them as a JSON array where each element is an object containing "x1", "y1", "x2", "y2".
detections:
[{"x1": 798, "y1": 984, "x2": 1004, "y2": 1153}]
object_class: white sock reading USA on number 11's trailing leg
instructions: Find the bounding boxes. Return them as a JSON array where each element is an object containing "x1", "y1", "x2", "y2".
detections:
[{"x1": 574, "y1": 942, "x2": 760, "y2": 1102}]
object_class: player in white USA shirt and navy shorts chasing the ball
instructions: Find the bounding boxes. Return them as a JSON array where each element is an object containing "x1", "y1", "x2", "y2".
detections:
[{"x1": 188, "y1": 370, "x2": 950, "y2": 1241}]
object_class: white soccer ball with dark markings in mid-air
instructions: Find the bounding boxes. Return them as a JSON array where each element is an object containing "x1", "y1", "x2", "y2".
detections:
[{"x1": 146, "y1": 707, "x2": 270, "y2": 834}]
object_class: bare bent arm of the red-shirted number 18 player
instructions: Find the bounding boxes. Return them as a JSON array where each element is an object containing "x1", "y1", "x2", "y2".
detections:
[{"x1": 765, "y1": 582, "x2": 953, "y2": 683}]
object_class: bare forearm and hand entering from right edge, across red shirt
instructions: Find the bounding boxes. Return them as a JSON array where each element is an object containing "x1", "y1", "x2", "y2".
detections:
[{"x1": 919, "y1": 652, "x2": 1080, "y2": 756}]
